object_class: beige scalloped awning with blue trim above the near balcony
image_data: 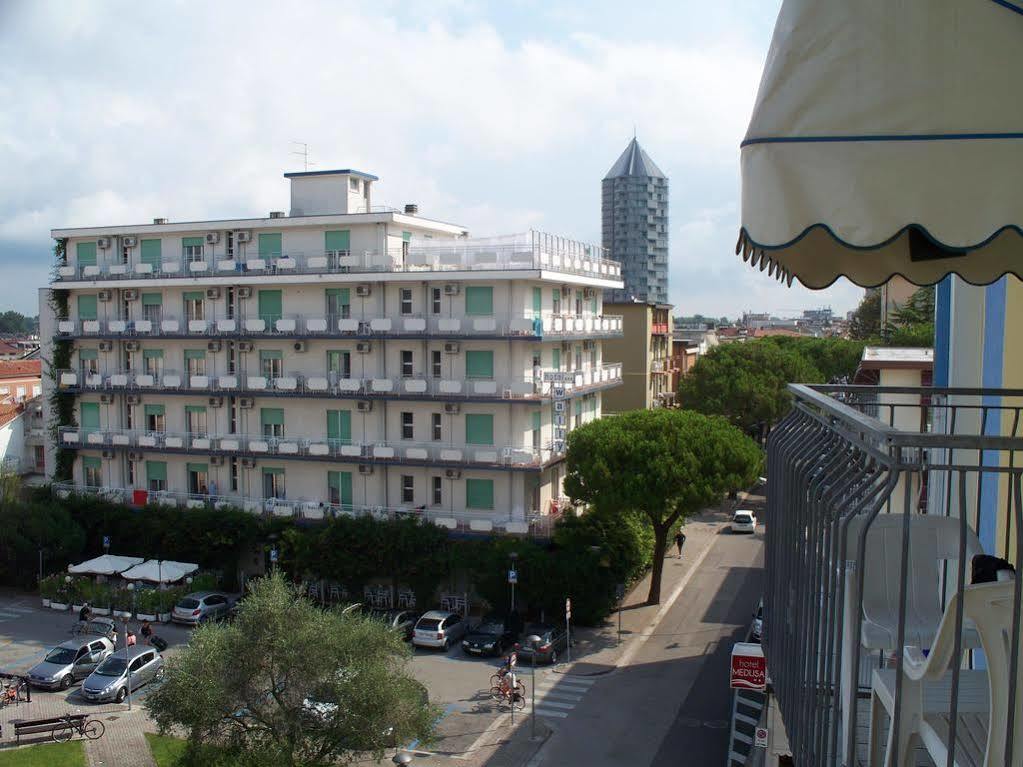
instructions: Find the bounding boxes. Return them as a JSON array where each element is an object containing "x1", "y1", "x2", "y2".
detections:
[{"x1": 737, "y1": 0, "x2": 1023, "y2": 288}]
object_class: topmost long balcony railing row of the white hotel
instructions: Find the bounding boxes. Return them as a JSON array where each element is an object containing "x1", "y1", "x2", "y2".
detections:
[{"x1": 57, "y1": 245, "x2": 621, "y2": 281}]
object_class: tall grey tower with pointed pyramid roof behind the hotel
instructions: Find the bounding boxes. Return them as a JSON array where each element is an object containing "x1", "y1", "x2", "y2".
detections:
[{"x1": 601, "y1": 137, "x2": 668, "y2": 304}]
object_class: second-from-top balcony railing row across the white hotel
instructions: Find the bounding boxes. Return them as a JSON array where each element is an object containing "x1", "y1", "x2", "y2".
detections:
[{"x1": 57, "y1": 314, "x2": 622, "y2": 340}]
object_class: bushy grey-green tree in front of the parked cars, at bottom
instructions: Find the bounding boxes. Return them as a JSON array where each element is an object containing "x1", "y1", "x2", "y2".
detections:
[{"x1": 145, "y1": 573, "x2": 438, "y2": 767}]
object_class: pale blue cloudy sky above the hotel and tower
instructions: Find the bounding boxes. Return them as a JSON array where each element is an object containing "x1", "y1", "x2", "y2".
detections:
[{"x1": 0, "y1": 0, "x2": 862, "y2": 317}]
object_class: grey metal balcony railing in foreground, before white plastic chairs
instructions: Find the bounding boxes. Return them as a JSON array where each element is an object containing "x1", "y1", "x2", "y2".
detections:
[{"x1": 763, "y1": 386, "x2": 1023, "y2": 767}]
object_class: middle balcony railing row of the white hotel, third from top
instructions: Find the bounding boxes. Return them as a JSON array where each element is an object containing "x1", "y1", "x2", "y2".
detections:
[{"x1": 57, "y1": 362, "x2": 622, "y2": 401}]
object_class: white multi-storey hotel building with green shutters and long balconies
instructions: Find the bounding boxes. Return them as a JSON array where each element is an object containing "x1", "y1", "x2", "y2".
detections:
[{"x1": 40, "y1": 170, "x2": 622, "y2": 534}]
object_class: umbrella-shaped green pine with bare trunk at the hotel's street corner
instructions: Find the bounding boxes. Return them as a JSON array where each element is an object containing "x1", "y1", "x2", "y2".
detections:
[{"x1": 565, "y1": 409, "x2": 762, "y2": 604}]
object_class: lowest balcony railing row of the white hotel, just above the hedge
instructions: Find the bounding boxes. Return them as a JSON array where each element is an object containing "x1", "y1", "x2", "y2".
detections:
[{"x1": 52, "y1": 483, "x2": 560, "y2": 538}]
